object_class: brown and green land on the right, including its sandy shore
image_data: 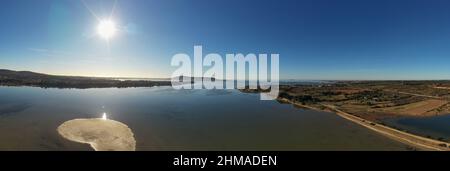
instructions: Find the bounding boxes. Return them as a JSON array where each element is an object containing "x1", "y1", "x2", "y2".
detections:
[{"x1": 241, "y1": 80, "x2": 450, "y2": 151}]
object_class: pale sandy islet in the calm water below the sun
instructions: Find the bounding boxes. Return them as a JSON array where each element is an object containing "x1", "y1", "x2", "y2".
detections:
[{"x1": 57, "y1": 118, "x2": 136, "y2": 151}]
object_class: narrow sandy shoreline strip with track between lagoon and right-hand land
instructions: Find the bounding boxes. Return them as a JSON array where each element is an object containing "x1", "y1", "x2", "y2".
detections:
[{"x1": 278, "y1": 98, "x2": 450, "y2": 151}]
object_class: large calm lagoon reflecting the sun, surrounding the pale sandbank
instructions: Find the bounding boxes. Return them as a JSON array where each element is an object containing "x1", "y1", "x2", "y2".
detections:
[{"x1": 0, "y1": 87, "x2": 406, "y2": 150}]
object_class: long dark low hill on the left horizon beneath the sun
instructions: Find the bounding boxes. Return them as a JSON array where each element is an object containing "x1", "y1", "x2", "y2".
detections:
[{"x1": 0, "y1": 69, "x2": 171, "y2": 88}]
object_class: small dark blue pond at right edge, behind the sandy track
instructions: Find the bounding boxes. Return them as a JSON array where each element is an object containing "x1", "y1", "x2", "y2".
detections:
[{"x1": 385, "y1": 115, "x2": 450, "y2": 141}]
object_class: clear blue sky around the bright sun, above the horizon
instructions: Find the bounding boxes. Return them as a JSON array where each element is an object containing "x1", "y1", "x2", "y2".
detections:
[{"x1": 0, "y1": 0, "x2": 450, "y2": 79}]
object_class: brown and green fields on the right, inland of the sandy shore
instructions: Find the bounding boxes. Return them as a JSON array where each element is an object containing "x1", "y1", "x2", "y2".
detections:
[{"x1": 272, "y1": 81, "x2": 450, "y2": 121}]
